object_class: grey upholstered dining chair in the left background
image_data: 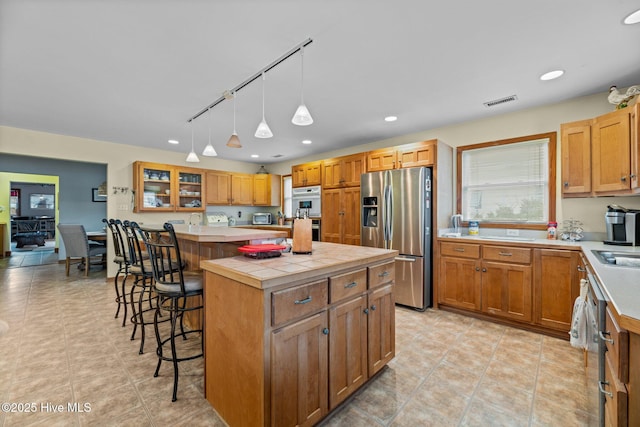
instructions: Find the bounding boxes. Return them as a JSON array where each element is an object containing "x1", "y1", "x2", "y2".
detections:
[{"x1": 58, "y1": 224, "x2": 107, "y2": 277}]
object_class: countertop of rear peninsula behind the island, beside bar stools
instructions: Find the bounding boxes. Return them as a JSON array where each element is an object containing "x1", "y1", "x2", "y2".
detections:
[{"x1": 173, "y1": 224, "x2": 287, "y2": 243}]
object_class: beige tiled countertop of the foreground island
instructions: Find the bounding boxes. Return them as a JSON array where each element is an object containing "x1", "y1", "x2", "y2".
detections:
[{"x1": 200, "y1": 242, "x2": 398, "y2": 289}]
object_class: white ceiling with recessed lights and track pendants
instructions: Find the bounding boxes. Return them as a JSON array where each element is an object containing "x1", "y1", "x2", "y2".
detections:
[{"x1": 0, "y1": 0, "x2": 640, "y2": 164}]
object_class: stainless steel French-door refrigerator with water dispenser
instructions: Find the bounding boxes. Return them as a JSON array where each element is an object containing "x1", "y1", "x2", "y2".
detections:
[{"x1": 360, "y1": 168, "x2": 432, "y2": 310}]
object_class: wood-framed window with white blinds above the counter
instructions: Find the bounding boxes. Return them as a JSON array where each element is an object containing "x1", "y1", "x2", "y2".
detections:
[{"x1": 457, "y1": 133, "x2": 556, "y2": 229}]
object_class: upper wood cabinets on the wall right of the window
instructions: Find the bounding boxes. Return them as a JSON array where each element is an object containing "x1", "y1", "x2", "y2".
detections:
[{"x1": 560, "y1": 108, "x2": 640, "y2": 197}]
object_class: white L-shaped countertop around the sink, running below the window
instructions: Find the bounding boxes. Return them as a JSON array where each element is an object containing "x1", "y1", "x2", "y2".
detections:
[{"x1": 438, "y1": 236, "x2": 640, "y2": 334}]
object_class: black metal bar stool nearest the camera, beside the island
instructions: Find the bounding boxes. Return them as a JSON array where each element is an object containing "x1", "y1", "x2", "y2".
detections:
[{"x1": 139, "y1": 222, "x2": 204, "y2": 402}]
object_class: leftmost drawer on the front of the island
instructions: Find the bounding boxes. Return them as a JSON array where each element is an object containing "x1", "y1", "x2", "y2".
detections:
[{"x1": 271, "y1": 279, "x2": 329, "y2": 326}]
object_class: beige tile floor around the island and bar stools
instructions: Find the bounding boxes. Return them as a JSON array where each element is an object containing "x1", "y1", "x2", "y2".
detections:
[{"x1": 0, "y1": 264, "x2": 596, "y2": 427}]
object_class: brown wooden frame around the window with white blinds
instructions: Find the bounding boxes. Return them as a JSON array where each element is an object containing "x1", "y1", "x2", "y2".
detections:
[{"x1": 456, "y1": 132, "x2": 557, "y2": 230}]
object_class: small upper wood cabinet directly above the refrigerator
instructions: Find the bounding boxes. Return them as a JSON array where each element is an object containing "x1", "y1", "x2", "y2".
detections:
[{"x1": 366, "y1": 140, "x2": 436, "y2": 172}]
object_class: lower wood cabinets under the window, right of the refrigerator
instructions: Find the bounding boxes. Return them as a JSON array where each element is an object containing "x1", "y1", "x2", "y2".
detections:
[{"x1": 437, "y1": 241, "x2": 581, "y2": 338}]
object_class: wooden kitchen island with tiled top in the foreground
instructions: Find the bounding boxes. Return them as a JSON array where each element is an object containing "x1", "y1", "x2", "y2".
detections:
[{"x1": 200, "y1": 242, "x2": 398, "y2": 427}]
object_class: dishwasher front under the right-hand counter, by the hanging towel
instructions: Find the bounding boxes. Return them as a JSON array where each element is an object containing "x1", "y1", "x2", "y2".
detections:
[{"x1": 585, "y1": 263, "x2": 611, "y2": 426}]
